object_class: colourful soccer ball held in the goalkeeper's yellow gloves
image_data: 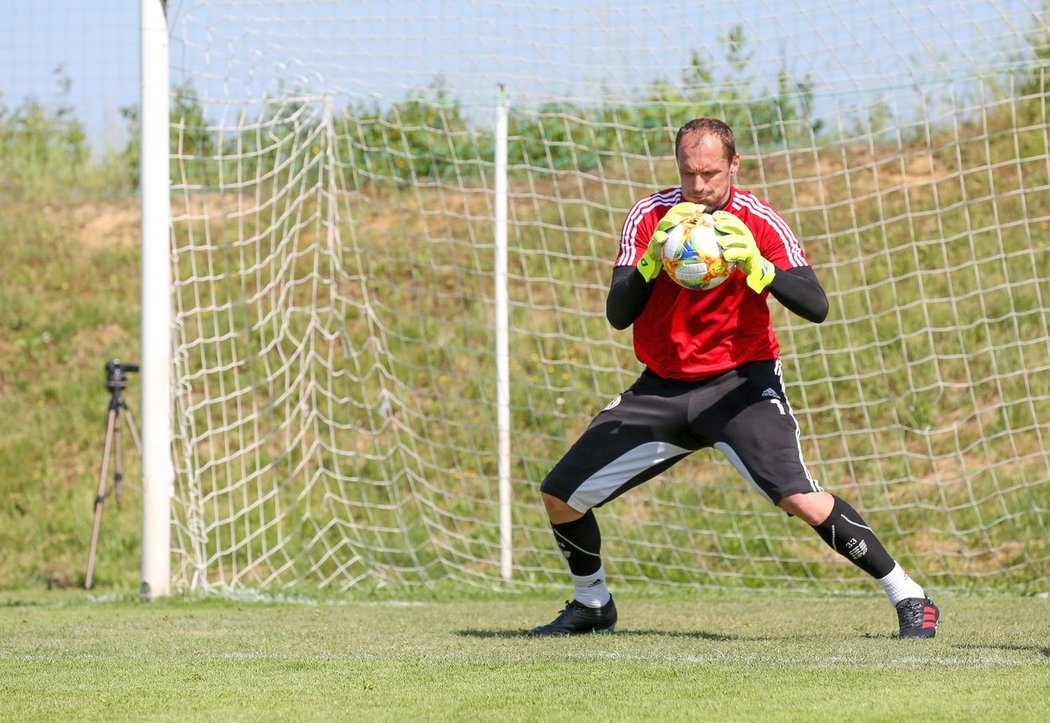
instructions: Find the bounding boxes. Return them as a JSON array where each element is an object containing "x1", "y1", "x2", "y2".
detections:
[{"x1": 664, "y1": 213, "x2": 733, "y2": 291}]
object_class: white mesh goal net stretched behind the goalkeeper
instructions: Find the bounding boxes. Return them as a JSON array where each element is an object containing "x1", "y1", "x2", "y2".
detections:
[{"x1": 168, "y1": 0, "x2": 1050, "y2": 591}]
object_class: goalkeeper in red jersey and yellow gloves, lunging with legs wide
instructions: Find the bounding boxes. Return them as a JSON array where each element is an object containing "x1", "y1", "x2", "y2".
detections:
[{"x1": 529, "y1": 118, "x2": 940, "y2": 638}]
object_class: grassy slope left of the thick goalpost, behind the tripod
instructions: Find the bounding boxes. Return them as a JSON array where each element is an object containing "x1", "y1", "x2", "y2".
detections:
[{"x1": 0, "y1": 199, "x2": 140, "y2": 587}]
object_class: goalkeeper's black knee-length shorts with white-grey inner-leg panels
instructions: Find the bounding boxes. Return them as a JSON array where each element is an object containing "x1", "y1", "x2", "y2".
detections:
[{"x1": 541, "y1": 360, "x2": 821, "y2": 512}]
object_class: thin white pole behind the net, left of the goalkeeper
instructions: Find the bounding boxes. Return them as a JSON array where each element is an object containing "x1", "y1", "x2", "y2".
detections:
[{"x1": 496, "y1": 85, "x2": 512, "y2": 583}]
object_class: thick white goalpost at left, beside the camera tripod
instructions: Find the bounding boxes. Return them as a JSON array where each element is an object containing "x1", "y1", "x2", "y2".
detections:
[{"x1": 140, "y1": 0, "x2": 174, "y2": 600}]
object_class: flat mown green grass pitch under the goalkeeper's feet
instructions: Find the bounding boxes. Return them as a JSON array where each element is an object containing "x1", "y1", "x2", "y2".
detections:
[{"x1": 0, "y1": 591, "x2": 1050, "y2": 721}]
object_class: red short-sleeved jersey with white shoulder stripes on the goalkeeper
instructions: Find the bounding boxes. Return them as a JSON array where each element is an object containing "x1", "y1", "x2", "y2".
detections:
[{"x1": 615, "y1": 187, "x2": 810, "y2": 381}]
